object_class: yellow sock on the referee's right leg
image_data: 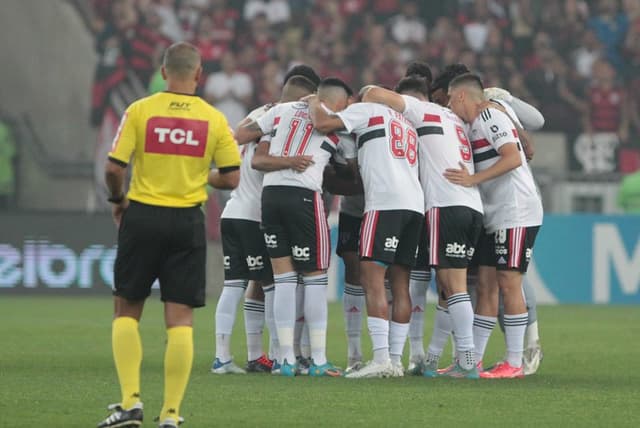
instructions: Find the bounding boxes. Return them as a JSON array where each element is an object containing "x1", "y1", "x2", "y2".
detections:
[{"x1": 160, "y1": 326, "x2": 193, "y2": 421}]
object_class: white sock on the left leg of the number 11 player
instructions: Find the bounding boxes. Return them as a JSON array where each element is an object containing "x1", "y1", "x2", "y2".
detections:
[{"x1": 273, "y1": 272, "x2": 298, "y2": 364}]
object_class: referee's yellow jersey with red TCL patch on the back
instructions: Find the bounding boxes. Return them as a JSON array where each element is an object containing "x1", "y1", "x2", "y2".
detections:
[{"x1": 109, "y1": 92, "x2": 240, "y2": 207}]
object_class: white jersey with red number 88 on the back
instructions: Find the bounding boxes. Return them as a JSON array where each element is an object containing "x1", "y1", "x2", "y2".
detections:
[{"x1": 336, "y1": 103, "x2": 424, "y2": 214}]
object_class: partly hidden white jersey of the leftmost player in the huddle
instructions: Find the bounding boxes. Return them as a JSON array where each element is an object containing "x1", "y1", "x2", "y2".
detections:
[{"x1": 220, "y1": 104, "x2": 272, "y2": 222}]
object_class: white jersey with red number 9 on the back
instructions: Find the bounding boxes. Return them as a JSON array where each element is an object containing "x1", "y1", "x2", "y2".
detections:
[{"x1": 402, "y1": 95, "x2": 482, "y2": 213}]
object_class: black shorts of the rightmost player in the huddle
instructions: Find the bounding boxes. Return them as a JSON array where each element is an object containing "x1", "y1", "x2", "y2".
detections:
[{"x1": 474, "y1": 226, "x2": 540, "y2": 273}]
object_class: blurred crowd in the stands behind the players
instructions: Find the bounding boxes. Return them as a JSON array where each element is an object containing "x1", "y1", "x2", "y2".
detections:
[{"x1": 87, "y1": 0, "x2": 640, "y2": 162}]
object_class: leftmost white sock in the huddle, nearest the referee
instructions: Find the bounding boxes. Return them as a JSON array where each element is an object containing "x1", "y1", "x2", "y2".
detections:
[{"x1": 216, "y1": 279, "x2": 248, "y2": 363}]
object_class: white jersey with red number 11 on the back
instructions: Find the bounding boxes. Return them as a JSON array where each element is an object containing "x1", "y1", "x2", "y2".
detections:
[{"x1": 257, "y1": 101, "x2": 356, "y2": 192}]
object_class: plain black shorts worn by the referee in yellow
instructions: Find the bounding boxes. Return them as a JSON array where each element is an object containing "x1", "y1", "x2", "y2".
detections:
[{"x1": 113, "y1": 201, "x2": 207, "y2": 307}]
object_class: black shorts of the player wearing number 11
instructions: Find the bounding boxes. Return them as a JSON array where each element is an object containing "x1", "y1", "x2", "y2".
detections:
[{"x1": 262, "y1": 186, "x2": 331, "y2": 272}]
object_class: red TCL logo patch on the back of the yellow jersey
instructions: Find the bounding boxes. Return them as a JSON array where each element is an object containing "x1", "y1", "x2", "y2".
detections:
[{"x1": 144, "y1": 117, "x2": 209, "y2": 158}]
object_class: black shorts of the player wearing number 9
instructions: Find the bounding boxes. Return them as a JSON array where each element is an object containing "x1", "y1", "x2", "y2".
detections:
[{"x1": 427, "y1": 206, "x2": 482, "y2": 269}]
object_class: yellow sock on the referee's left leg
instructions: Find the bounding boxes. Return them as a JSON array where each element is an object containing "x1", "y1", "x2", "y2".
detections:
[{"x1": 111, "y1": 317, "x2": 142, "y2": 409}]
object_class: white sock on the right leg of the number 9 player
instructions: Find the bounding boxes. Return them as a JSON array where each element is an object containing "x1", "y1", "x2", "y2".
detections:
[{"x1": 447, "y1": 293, "x2": 475, "y2": 370}]
